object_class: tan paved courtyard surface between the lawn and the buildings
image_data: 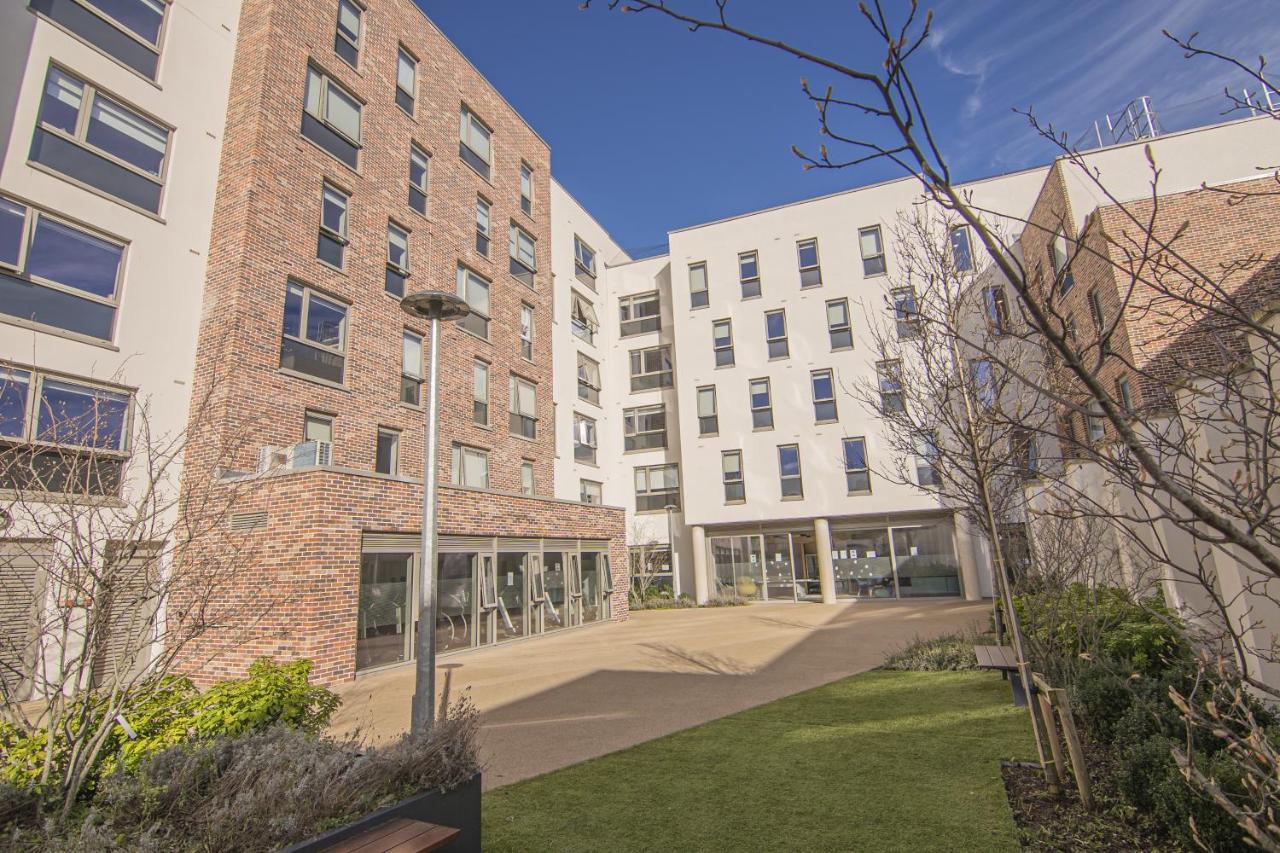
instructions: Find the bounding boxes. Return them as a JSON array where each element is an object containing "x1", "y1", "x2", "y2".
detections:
[{"x1": 332, "y1": 599, "x2": 991, "y2": 789}]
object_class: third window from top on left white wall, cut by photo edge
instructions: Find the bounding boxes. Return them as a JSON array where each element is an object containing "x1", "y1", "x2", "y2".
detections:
[{"x1": 0, "y1": 196, "x2": 124, "y2": 341}]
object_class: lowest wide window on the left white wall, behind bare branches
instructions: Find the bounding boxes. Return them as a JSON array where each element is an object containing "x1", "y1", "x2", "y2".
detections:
[{"x1": 0, "y1": 368, "x2": 132, "y2": 496}]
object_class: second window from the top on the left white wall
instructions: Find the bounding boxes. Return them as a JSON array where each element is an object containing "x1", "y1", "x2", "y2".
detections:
[{"x1": 31, "y1": 65, "x2": 170, "y2": 213}]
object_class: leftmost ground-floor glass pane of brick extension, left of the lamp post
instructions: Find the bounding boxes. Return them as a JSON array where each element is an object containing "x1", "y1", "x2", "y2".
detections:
[{"x1": 356, "y1": 553, "x2": 413, "y2": 670}]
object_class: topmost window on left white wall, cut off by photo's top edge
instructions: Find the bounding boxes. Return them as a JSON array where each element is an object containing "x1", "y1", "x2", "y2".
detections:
[{"x1": 31, "y1": 0, "x2": 169, "y2": 79}]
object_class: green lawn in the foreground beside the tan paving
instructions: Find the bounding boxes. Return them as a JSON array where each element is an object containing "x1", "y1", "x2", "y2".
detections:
[{"x1": 484, "y1": 671, "x2": 1034, "y2": 853}]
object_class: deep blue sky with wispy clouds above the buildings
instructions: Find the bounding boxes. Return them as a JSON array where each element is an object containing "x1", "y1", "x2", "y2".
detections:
[{"x1": 416, "y1": 0, "x2": 1280, "y2": 257}]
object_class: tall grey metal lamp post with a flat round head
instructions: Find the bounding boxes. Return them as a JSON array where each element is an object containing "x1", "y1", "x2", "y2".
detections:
[{"x1": 401, "y1": 291, "x2": 471, "y2": 733}]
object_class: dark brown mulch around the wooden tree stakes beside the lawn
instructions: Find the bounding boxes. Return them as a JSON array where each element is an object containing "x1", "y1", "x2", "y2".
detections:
[{"x1": 1004, "y1": 742, "x2": 1183, "y2": 853}]
